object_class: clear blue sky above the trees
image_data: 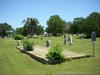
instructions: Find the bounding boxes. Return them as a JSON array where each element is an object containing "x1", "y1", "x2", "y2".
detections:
[{"x1": 0, "y1": 0, "x2": 100, "y2": 29}]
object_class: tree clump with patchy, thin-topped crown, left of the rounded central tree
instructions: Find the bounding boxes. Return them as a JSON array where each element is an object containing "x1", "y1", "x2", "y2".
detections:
[{"x1": 16, "y1": 18, "x2": 44, "y2": 36}]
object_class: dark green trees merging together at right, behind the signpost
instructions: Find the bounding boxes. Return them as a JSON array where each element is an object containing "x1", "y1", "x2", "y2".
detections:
[{"x1": 71, "y1": 12, "x2": 100, "y2": 38}]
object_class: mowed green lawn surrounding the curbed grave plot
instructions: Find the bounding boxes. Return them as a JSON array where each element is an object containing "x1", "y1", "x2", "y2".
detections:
[{"x1": 0, "y1": 36, "x2": 100, "y2": 75}]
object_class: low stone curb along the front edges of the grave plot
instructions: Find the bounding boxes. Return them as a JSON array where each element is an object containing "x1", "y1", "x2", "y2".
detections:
[{"x1": 16, "y1": 46, "x2": 90, "y2": 64}]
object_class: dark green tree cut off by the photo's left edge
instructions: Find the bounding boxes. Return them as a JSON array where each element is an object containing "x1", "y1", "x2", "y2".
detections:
[{"x1": 0, "y1": 23, "x2": 14, "y2": 38}]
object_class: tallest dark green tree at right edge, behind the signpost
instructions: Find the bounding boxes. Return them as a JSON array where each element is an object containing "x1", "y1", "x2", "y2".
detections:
[{"x1": 83, "y1": 12, "x2": 100, "y2": 37}]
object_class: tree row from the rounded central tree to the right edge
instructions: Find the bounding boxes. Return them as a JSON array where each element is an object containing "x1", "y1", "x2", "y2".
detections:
[{"x1": 46, "y1": 12, "x2": 100, "y2": 37}]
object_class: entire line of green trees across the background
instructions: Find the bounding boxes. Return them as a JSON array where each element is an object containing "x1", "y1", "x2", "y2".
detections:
[{"x1": 0, "y1": 12, "x2": 100, "y2": 37}]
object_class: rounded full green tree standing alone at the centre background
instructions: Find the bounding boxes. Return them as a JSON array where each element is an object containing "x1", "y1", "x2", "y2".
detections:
[{"x1": 46, "y1": 15, "x2": 65, "y2": 36}]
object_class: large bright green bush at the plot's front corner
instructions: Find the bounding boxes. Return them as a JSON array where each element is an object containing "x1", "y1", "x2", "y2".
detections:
[{"x1": 46, "y1": 45, "x2": 64, "y2": 60}]
